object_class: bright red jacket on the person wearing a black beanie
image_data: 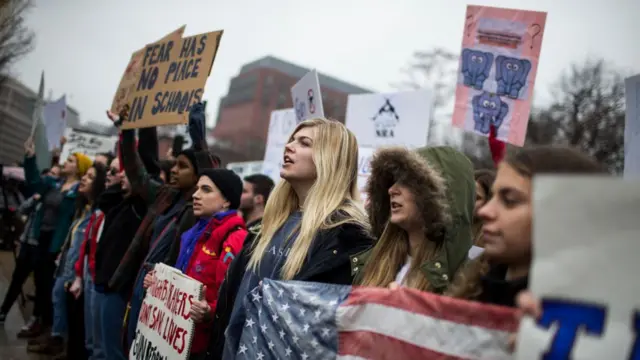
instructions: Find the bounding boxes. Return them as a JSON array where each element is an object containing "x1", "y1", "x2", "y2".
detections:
[{"x1": 185, "y1": 214, "x2": 248, "y2": 354}]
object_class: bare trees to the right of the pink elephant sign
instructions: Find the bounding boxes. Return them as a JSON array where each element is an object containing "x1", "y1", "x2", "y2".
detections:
[{"x1": 527, "y1": 60, "x2": 625, "y2": 172}]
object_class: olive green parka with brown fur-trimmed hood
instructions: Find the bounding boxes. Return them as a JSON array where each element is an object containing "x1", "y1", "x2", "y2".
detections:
[{"x1": 351, "y1": 146, "x2": 475, "y2": 293}]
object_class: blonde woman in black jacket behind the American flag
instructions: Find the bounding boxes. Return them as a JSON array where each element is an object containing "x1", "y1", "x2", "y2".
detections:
[{"x1": 219, "y1": 119, "x2": 373, "y2": 359}]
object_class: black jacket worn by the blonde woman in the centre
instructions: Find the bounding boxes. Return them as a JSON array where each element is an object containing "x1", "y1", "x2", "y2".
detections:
[{"x1": 207, "y1": 218, "x2": 373, "y2": 360}]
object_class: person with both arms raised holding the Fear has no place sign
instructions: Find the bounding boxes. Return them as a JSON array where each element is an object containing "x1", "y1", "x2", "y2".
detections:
[{"x1": 107, "y1": 103, "x2": 220, "y2": 353}]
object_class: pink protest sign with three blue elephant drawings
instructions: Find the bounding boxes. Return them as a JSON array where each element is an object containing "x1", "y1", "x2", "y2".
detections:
[{"x1": 452, "y1": 5, "x2": 547, "y2": 146}]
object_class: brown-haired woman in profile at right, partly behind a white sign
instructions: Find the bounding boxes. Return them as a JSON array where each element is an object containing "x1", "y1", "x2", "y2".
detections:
[{"x1": 447, "y1": 146, "x2": 606, "y2": 307}]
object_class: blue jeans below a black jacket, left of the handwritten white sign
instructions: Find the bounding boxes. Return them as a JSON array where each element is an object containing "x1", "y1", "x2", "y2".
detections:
[{"x1": 95, "y1": 291, "x2": 129, "y2": 360}]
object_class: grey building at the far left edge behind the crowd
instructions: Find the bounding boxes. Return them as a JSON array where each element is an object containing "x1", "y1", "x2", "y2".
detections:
[{"x1": 0, "y1": 77, "x2": 80, "y2": 165}]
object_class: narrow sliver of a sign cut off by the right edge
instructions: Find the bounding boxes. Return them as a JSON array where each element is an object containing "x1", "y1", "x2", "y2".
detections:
[{"x1": 624, "y1": 74, "x2": 640, "y2": 178}]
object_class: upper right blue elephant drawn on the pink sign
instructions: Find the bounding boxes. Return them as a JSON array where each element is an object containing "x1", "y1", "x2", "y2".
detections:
[{"x1": 496, "y1": 55, "x2": 531, "y2": 99}]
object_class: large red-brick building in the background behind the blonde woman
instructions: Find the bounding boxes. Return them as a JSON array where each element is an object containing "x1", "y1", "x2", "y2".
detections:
[{"x1": 213, "y1": 56, "x2": 371, "y2": 163}]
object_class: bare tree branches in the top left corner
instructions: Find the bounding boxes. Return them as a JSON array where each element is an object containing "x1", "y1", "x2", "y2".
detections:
[{"x1": 0, "y1": 0, "x2": 35, "y2": 82}]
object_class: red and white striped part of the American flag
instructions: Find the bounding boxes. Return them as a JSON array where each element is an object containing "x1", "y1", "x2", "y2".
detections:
[{"x1": 337, "y1": 287, "x2": 518, "y2": 360}]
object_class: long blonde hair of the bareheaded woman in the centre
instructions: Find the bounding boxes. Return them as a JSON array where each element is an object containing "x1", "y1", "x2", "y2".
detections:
[{"x1": 247, "y1": 118, "x2": 369, "y2": 280}]
